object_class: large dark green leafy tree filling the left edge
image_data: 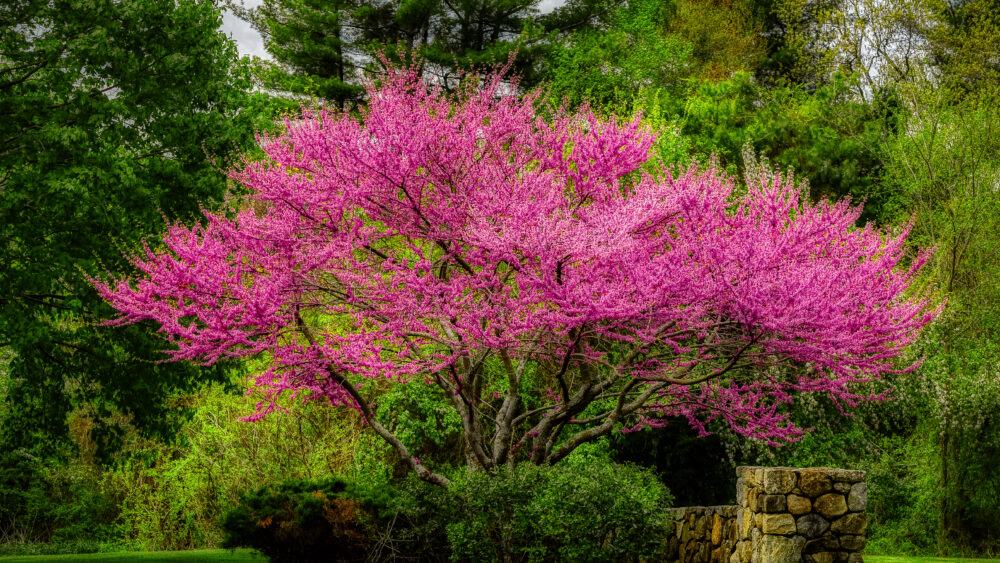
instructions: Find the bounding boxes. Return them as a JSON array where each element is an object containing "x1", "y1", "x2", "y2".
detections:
[{"x1": 0, "y1": 0, "x2": 253, "y2": 454}]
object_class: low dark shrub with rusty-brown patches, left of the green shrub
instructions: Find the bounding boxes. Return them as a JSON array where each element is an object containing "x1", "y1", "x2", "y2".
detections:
[{"x1": 222, "y1": 478, "x2": 388, "y2": 562}]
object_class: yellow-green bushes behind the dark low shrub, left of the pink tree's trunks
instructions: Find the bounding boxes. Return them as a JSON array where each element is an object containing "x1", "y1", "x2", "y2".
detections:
[{"x1": 106, "y1": 387, "x2": 390, "y2": 549}]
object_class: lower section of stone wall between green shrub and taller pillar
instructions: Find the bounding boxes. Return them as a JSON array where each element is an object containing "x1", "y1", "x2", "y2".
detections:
[{"x1": 667, "y1": 506, "x2": 739, "y2": 563}]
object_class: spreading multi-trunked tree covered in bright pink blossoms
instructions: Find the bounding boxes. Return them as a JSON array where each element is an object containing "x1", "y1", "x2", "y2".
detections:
[{"x1": 94, "y1": 65, "x2": 937, "y2": 485}]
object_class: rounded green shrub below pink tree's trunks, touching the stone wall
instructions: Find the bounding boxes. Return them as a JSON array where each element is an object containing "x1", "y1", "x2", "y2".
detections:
[{"x1": 383, "y1": 459, "x2": 672, "y2": 562}]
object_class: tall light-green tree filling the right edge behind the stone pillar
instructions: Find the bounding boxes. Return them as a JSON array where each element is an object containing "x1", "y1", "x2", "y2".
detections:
[{"x1": 872, "y1": 81, "x2": 1000, "y2": 549}]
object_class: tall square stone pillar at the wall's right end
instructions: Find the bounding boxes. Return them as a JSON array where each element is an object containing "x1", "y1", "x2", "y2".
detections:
[{"x1": 730, "y1": 467, "x2": 868, "y2": 563}]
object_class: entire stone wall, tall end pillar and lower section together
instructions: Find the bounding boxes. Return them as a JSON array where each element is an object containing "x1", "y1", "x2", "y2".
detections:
[{"x1": 668, "y1": 467, "x2": 868, "y2": 563}]
